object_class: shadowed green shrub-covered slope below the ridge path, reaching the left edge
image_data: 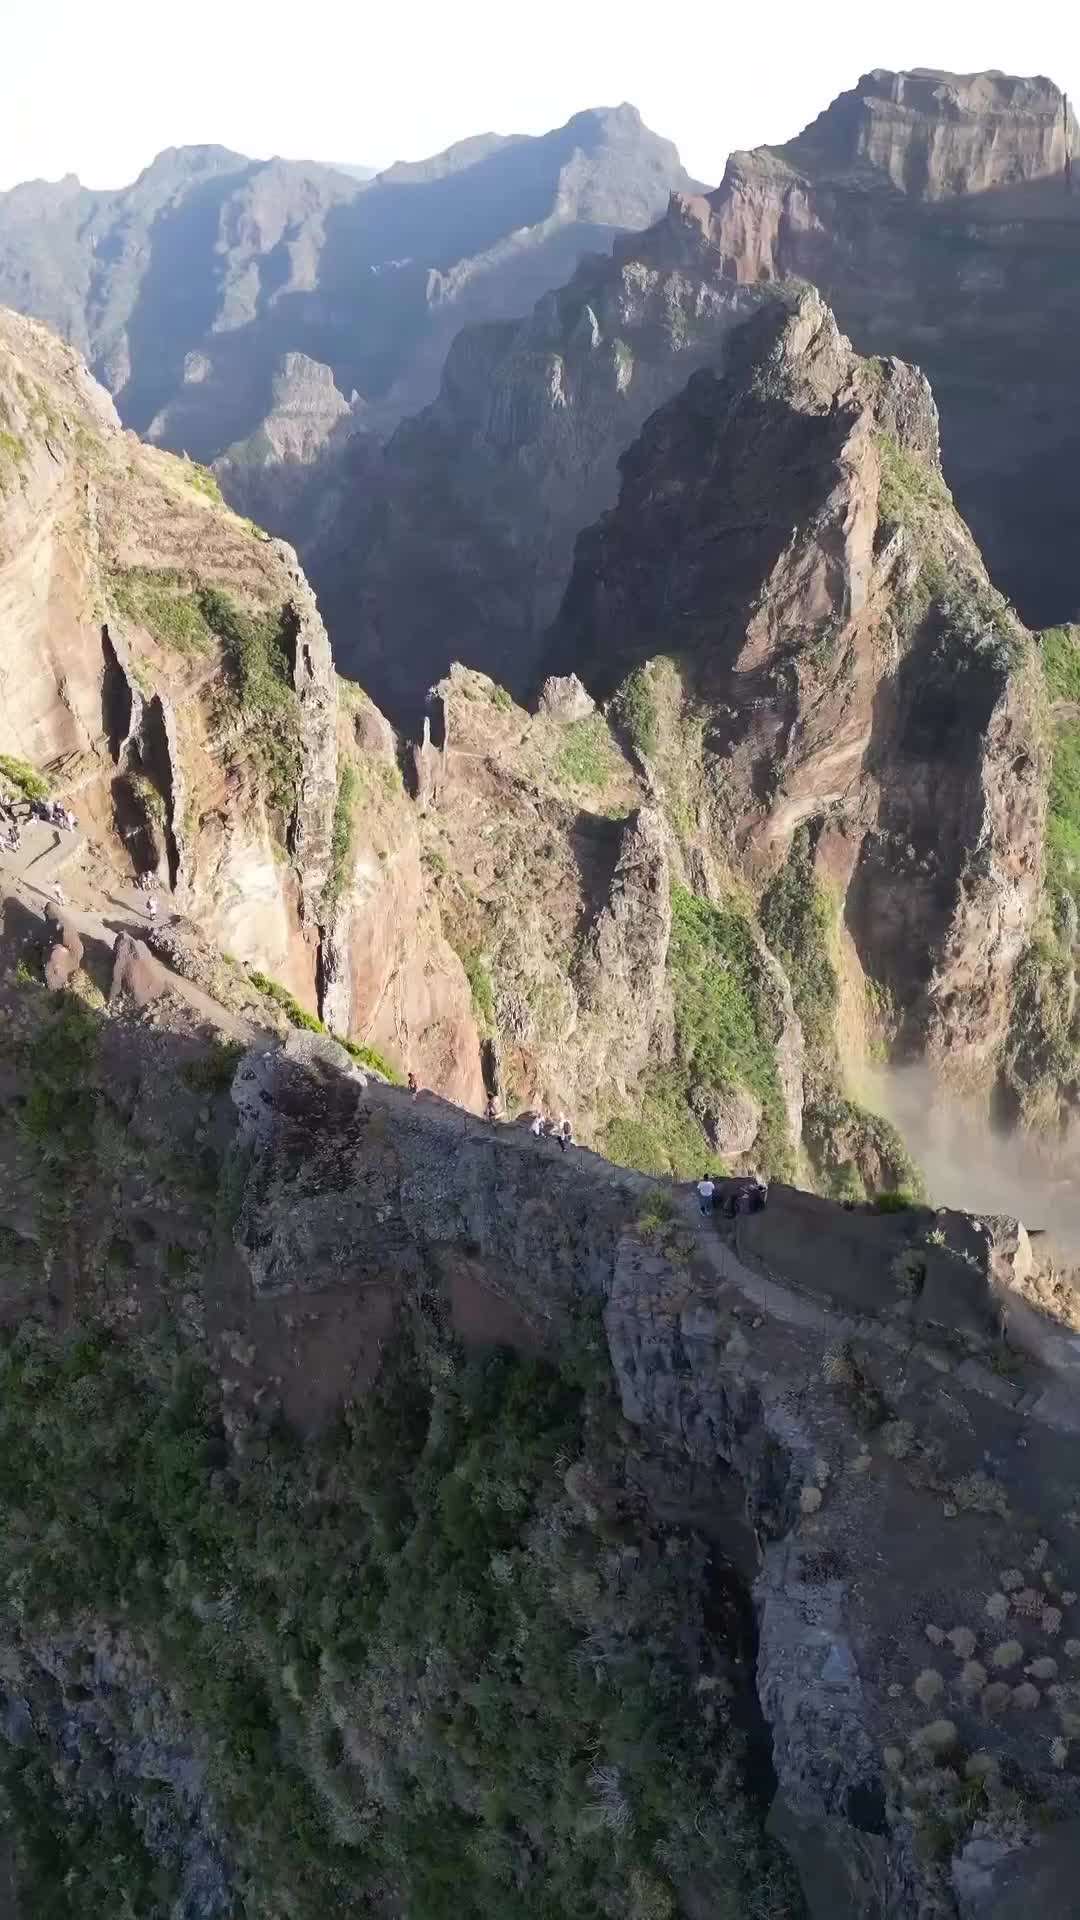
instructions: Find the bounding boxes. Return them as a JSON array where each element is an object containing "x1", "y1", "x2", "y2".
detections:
[{"x1": 0, "y1": 987, "x2": 799, "y2": 1920}]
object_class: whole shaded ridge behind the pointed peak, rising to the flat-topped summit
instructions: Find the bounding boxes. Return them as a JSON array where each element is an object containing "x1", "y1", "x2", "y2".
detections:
[{"x1": 303, "y1": 73, "x2": 1080, "y2": 718}]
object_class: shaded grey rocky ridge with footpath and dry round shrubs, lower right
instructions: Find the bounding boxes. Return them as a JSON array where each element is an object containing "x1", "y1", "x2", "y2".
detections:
[{"x1": 220, "y1": 1058, "x2": 1080, "y2": 1920}]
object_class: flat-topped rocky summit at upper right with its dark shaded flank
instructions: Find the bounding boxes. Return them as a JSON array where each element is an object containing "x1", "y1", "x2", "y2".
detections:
[{"x1": 709, "y1": 71, "x2": 1080, "y2": 626}]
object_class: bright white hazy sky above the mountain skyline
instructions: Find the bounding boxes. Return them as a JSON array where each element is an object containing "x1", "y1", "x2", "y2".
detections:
[{"x1": 0, "y1": 0, "x2": 1080, "y2": 188}]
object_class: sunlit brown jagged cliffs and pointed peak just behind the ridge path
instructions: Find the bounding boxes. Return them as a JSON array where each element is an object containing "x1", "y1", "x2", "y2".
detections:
[{"x1": 0, "y1": 293, "x2": 1045, "y2": 1188}]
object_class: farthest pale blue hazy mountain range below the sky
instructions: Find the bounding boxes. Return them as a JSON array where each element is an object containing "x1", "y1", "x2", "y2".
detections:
[{"x1": 0, "y1": 106, "x2": 690, "y2": 461}]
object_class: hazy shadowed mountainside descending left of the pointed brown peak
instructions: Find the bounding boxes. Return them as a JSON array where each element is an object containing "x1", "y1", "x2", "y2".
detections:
[{"x1": 303, "y1": 200, "x2": 757, "y2": 724}]
